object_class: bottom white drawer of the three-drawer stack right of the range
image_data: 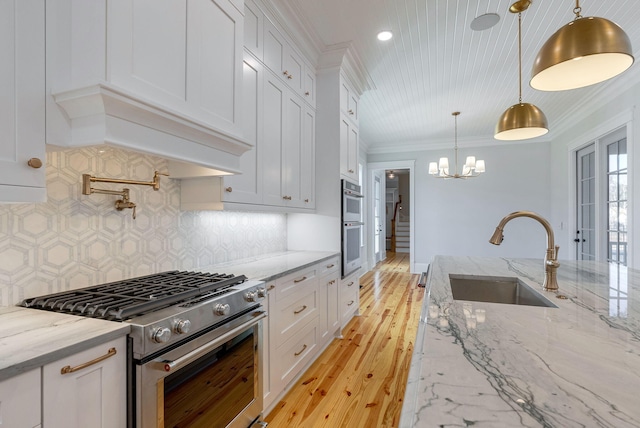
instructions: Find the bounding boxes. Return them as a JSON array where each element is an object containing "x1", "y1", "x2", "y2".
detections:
[{"x1": 276, "y1": 322, "x2": 318, "y2": 385}]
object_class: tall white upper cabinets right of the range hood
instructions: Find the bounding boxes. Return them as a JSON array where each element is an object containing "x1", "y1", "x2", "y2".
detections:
[{"x1": 175, "y1": 0, "x2": 316, "y2": 212}]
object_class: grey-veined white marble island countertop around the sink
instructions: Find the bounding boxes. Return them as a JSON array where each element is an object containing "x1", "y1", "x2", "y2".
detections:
[{"x1": 400, "y1": 256, "x2": 640, "y2": 428}]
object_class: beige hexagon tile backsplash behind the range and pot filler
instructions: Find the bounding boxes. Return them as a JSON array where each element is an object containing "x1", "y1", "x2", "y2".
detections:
[{"x1": 0, "y1": 146, "x2": 287, "y2": 307}]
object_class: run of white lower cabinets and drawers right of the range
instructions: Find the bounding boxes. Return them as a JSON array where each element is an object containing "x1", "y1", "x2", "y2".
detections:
[{"x1": 263, "y1": 257, "x2": 359, "y2": 414}]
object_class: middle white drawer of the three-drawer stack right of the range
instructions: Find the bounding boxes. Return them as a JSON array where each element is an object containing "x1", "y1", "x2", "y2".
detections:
[{"x1": 274, "y1": 288, "x2": 318, "y2": 347}]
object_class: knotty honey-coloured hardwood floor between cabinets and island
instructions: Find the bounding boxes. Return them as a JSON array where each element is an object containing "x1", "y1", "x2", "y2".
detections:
[{"x1": 265, "y1": 253, "x2": 424, "y2": 428}]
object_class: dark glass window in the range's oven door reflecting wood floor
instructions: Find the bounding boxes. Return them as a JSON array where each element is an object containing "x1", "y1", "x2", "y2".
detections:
[{"x1": 164, "y1": 328, "x2": 256, "y2": 427}]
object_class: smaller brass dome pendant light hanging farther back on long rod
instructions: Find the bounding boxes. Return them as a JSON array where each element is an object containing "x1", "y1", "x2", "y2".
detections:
[{"x1": 494, "y1": 0, "x2": 549, "y2": 141}]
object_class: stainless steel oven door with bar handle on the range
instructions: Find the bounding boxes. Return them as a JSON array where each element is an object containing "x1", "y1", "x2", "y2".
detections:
[{"x1": 135, "y1": 308, "x2": 266, "y2": 428}]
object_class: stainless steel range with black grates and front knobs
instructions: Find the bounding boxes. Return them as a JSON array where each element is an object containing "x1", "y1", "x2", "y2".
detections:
[{"x1": 22, "y1": 271, "x2": 267, "y2": 428}]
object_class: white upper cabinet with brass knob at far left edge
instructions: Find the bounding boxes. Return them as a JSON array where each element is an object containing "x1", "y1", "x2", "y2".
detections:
[{"x1": 0, "y1": 0, "x2": 47, "y2": 203}]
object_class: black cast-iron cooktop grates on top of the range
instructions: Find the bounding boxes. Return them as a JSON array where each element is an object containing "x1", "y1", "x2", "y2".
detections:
[{"x1": 21, "y1": 271, "x2": 247, "y2": 321}]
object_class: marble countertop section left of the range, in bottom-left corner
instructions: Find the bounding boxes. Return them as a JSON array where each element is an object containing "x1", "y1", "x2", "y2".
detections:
[{"x1": 0, "y1": 306, "x2": 130, "y2": 381}]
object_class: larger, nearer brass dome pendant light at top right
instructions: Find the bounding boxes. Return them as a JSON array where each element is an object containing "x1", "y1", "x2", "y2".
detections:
[{"x1": 530, "y1": 0, "x2": 634, "y2": 91}]
